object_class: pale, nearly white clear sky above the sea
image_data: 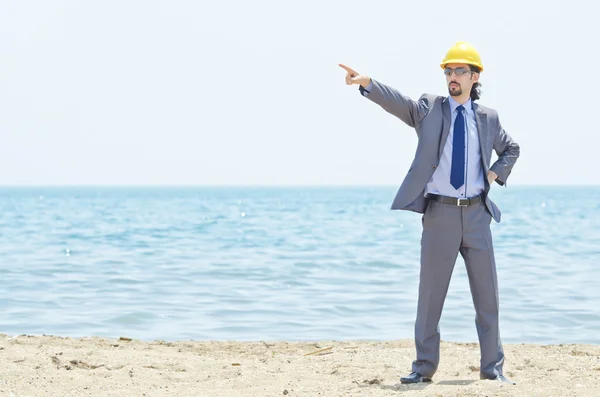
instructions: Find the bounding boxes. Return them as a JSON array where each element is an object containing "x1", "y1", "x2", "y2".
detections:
[{"x1": 0, "y1": 0, "x2": 600, "y2": 186}]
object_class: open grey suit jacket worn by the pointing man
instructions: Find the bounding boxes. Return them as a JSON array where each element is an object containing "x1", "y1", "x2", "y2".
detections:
[{"x1": 367, "y1": 79, "x2": 520, "y2": 222}]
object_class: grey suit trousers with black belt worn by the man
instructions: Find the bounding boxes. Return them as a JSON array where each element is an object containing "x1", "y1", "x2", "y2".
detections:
[{"x1": 412, "y1": 201, "x2": 504, "y2": 378}]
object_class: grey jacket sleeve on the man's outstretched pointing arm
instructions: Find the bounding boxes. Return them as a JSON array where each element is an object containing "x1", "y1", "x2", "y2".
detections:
[{"x1": 359, "y1": 79, "x2": 429, "y2": 127}]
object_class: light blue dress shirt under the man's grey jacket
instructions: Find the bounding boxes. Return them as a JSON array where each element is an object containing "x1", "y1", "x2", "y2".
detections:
[{"x1": 363, "y1": 83, "x2": 485, "y2": 198}]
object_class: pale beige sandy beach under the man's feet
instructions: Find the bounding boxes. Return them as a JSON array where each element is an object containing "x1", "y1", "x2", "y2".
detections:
[{"x1": 0, "y1": 334, "x2": 600, "y2": 397}]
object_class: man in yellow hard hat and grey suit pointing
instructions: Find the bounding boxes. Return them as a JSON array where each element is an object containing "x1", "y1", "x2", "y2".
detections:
[{"x1": 340, "y1": 42, "x2": 520, "y2": 383}]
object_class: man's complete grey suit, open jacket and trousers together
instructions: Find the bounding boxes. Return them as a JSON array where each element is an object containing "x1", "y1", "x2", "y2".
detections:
[{"x1": 361, "y1": 80, "x2": 520, "y2": 378}]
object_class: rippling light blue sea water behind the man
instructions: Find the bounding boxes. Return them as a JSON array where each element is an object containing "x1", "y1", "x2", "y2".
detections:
[{"x1": 0, "y1": 186, "x2": 600, "y2": 344}]
